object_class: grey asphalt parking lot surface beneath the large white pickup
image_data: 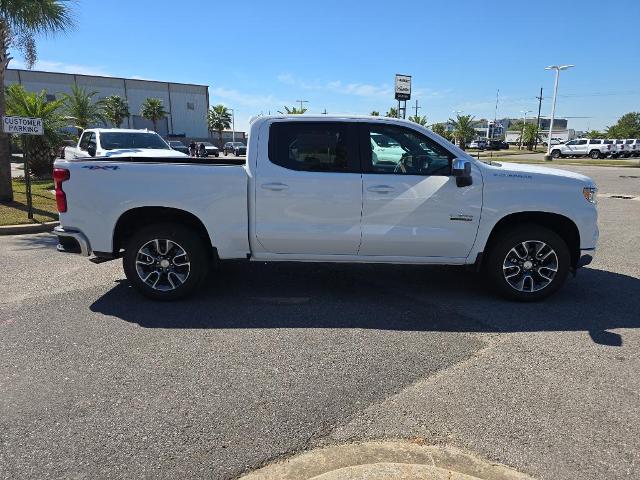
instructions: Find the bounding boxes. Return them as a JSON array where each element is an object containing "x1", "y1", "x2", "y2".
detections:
[{"x1": 0, "y1": 167, "x2": 640, "y2": 480}]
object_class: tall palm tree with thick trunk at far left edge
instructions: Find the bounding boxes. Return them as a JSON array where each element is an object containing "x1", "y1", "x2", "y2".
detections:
[{"x1": 0, "y1": 0, "x2": 72, "y2": 202}]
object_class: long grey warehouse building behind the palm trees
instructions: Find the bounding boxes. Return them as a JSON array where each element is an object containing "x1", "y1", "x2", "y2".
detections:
[{"x1": 5, "y1": 69, "x2": 209, "y2": 139}]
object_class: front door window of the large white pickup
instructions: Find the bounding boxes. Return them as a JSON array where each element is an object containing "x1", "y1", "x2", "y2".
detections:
[{"x1": 365, "y1": 125, "x2": 455, "y2": 175}]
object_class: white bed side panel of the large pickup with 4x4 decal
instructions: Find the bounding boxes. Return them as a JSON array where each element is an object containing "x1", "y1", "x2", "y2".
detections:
[{"x1": 55, "y1": 157, "x2": 249, "y2": 258}]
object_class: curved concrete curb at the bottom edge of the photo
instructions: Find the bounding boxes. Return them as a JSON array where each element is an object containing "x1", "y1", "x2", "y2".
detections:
[{"x1": 241, "y1": 441, "x2": 533, "y2": 480}]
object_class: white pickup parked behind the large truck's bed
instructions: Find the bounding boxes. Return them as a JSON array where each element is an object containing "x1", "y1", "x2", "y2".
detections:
[{"x1": 63, "y1": 128, "x2": 188, "y2": 159}]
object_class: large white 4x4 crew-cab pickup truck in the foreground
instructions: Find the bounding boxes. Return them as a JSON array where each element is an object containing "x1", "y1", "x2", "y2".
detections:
[{"x1": 54, "y1": 115, "x2": 598, "y2": 301}]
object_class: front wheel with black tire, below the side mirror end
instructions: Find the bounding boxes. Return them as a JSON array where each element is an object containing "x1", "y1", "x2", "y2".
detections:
[{"x1": 484, "y1": 224, "x2": 571, "y2": 302}]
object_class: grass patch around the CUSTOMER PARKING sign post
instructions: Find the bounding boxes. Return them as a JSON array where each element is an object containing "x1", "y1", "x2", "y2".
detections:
[{"x1": 0, "y1": 178, "x2": 58, "y2": 225}]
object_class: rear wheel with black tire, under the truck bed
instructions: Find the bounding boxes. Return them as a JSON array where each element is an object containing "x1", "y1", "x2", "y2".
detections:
[{"x1": 122, "y1": 223, "x2": 210, "y2": 300}]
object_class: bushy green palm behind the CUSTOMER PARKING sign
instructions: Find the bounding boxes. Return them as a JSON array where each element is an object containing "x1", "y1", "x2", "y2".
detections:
[{"x1": 6, "y1": 83, "x2": 66, "y2": 176}]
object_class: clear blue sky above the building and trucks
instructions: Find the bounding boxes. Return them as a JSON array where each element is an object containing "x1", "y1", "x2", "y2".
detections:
[{"x1": 10, "y1": 0, "x2": 640, "y2": 129}]
